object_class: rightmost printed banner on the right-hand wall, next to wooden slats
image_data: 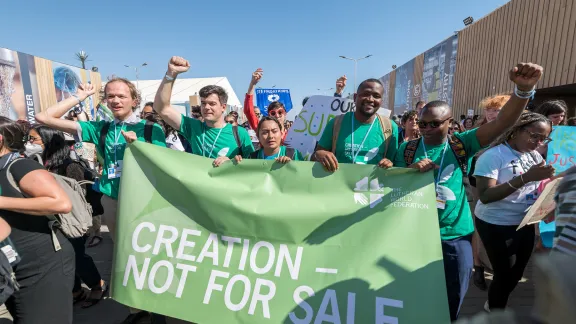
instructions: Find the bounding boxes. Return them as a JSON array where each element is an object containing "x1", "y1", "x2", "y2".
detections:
[{"x1": 422, "y1": 35, "x2": 458, "y2": 106}]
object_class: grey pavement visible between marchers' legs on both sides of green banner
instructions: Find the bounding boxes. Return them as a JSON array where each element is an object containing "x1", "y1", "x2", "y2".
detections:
[{"x1": 74, "y1": 226, "x2": 535, "y2": 324}]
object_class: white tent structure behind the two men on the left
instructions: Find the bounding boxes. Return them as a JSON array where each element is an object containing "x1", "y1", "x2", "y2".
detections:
[{"x1": 132, "y1": 77, "x2": 242, "y2": 115}]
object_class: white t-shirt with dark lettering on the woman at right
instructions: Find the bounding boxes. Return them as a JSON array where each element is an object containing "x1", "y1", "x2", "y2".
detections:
[{"x1": 474, "y1": 144, "x2": 543, "y2": 225}]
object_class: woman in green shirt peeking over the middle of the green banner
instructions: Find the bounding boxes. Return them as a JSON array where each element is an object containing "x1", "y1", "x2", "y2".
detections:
[{"x1": 214, "y1": 116, "x2": 304, "y2": 167}]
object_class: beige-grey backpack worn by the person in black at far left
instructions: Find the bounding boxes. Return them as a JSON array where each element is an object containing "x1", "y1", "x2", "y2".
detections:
[{"x1": 6, "y1": 158, "x2": 92, "y2": 251}]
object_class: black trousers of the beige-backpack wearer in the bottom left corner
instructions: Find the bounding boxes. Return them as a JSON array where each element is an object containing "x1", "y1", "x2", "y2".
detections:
[{"x1": 6, "y1": 233, "x2": 74, "y2": 324}]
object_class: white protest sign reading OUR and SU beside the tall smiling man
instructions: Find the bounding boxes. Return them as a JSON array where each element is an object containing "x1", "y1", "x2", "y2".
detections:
[{"x1": 285, "y1": 96, "x2": 356, "y2": 160}]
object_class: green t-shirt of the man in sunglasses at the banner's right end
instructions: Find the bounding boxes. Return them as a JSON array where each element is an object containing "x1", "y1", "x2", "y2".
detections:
[{"x1": 394, "y1": 129, "x2": 482, "y2": 240}]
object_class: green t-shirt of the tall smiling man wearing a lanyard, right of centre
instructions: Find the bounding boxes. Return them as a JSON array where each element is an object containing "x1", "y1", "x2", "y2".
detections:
[{"x1": 318, "y1": 112, "x2": 398, "y2": 164}]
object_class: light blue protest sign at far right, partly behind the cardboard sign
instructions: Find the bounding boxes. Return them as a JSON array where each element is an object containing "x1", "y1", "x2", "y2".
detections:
[{"x1": 539, "y1": 126, "x2": 576, "y2": 248}]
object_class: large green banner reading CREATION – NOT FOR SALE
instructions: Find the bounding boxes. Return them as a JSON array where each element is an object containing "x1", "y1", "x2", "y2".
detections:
[{"x1": 112, "y1": 143, "x2": 450, "y2": 324}]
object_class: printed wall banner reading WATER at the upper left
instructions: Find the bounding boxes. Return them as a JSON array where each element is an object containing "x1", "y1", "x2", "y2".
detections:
[{"x1": 0, "y1": 48, "x2": 100, "y2": 124}]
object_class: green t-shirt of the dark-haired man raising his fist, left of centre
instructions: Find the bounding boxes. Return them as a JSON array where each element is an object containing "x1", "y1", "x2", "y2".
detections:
[{"x1": 180, "y1": 115, "x2": 254, "y2": 159}]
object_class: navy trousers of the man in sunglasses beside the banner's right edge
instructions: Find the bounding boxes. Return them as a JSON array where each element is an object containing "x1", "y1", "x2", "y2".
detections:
[{"x1": 442, "y1": 234, "x2": 474, "y2": 321}]
